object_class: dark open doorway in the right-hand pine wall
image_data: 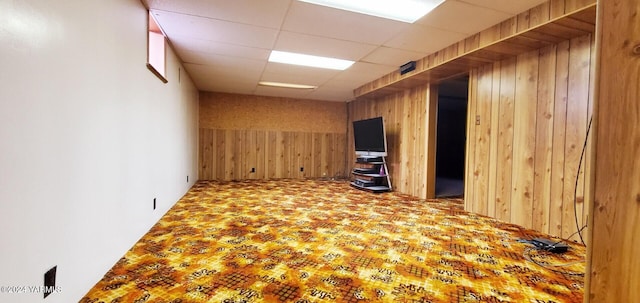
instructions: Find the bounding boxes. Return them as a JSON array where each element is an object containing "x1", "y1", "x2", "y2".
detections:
[{"x1": 436, "y1": 76, "x2": 469, "y2": 198}]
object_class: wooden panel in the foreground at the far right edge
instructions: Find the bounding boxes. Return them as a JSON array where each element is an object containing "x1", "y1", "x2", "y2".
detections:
[{"x1": 585, "y1": 0, "x2": 640, "y2": 303}]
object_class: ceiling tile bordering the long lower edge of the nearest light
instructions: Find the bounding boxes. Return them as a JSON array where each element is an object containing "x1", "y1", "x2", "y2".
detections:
[{"x1": 282, "y1": 1, "x2": 409, "y2": 45}]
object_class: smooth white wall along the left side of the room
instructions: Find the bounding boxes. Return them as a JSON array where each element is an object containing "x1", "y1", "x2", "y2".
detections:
[{"x1": 0, "y1": 0, "x2": 198, "y2": 303}]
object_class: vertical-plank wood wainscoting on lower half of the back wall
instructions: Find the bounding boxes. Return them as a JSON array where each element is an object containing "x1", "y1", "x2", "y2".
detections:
[{"x1": 199, "y1": 128, "x2": 347, "y2": 180}]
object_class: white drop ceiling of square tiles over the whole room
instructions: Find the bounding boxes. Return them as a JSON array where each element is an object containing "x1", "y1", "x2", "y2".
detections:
[{"x1": 143, "y1": 0, "x2": 545, "y2": 102}]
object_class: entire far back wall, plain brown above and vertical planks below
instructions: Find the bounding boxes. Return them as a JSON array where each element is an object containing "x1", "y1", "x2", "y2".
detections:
[{"x1": 198, "y1": 92, "x2": 347, "y2": 180}]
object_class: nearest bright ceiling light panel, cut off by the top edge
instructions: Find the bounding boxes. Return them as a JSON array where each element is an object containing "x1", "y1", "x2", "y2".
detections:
[{"x1": 299, "y1": 0, "x2": 444, "y2": 23}]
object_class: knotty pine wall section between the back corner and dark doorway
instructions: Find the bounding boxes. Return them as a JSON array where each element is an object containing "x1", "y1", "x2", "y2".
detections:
[{"x1": 347, "y1": 85, "x2": 437, "y2": 198}]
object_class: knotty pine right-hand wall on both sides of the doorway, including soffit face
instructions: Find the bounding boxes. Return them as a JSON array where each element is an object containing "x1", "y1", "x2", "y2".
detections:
[{"x1": 348, "y1": 0, "x2": 595, "y2": 240}]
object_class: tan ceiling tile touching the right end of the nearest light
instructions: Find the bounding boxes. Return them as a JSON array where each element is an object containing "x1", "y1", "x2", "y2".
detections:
[{"x1": 417, "y1": 0, "x2": 516, "y2": 35}]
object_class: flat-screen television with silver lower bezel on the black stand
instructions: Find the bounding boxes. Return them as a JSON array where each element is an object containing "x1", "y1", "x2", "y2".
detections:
[{"x1": 353, "y1": 117, "x2": 387, "y2": 157}]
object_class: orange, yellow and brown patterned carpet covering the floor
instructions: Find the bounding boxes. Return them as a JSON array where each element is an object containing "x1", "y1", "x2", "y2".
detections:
[{"x1": 80, "y1": 180, "x2": 585, "y2": 303}]
